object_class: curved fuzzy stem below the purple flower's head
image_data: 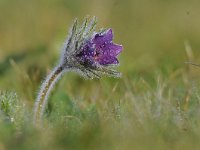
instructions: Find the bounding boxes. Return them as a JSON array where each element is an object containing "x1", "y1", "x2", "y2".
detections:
[{"x1": 33, "y1": 66, "x2": 64, "y2": 126}]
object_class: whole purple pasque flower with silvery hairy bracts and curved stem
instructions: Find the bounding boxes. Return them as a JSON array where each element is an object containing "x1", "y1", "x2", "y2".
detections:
[{"x1": 34, "y1": 17, "x2": 122, "y2": 125}]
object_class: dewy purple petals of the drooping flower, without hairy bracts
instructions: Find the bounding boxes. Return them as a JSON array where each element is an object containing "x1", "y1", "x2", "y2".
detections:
[{"x1": 77, "y1": 29, "x2": 122, "y2": 65}]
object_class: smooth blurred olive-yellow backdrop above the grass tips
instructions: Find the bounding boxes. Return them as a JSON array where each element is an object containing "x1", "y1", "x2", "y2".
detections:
[{"x1": 0, "y1": 0, "x2": 200, "y2": 88}]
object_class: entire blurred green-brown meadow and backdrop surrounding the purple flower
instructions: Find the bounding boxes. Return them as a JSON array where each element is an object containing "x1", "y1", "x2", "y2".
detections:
[{"x1": 0, "y1": 0, "x2": 200, "y2": 150}]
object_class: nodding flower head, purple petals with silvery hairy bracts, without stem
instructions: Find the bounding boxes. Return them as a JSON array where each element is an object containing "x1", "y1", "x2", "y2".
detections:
[{"x1": 60, "y1": 17, "x2": 122, "y2": 79}]
